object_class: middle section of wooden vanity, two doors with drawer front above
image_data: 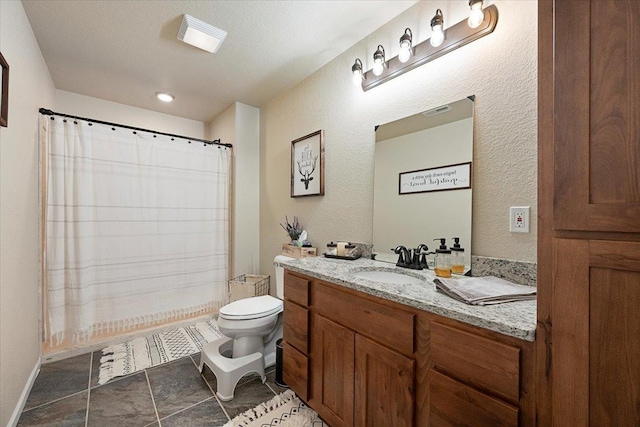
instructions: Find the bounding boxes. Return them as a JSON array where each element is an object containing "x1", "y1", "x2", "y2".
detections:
[{"x1": 309, "y1": 280, "x2": 415, "y2": 427}]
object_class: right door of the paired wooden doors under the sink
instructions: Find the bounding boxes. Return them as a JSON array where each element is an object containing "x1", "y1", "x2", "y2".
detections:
[{"x1": 354, "y1": 335, "x2": 415, "y2": 427}]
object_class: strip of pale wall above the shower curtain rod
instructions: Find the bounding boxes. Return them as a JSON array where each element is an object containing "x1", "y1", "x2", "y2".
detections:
[{"x1": 55, "y1": 89, "x2": 207, "y2": 139}]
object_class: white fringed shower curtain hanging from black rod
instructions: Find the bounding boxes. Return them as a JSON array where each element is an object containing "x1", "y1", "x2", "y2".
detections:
[{"x1": 42, "y1": 117, "x2": 231, "y2": 346}]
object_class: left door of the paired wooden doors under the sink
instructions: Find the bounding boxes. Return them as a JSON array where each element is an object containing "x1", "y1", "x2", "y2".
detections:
[{"x1": 311, "y1": 315, "x2": 355, "y2": 427}]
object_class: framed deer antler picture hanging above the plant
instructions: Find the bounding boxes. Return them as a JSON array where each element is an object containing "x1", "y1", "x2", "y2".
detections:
[{"x1": 291, "y1": 130, "x2": 324, "y2": 197}]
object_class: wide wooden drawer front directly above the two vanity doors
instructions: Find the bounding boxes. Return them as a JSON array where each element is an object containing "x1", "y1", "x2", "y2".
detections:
[{"x1": 313, "y1": 283, "x2": 414, "y2": 355}]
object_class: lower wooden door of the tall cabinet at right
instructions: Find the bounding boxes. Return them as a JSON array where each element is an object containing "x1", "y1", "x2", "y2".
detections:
[{"x1": 551, "y1": 239, "x2": 640, "y2": 427}]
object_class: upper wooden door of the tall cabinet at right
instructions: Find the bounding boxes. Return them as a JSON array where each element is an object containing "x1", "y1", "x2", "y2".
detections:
[{"x1": 543, "y1": 0, "x2": 640, "y2": 232}]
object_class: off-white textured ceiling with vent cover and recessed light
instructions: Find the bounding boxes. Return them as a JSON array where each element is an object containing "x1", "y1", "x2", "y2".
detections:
[{"x1": 22, "y1": 0, "x2": 415, "y2": 122}]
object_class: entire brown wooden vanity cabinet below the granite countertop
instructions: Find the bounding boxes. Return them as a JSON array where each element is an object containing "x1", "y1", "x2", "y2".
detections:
[{"x1": 283, "y1": 271, "x2": 535, "y2": 427}]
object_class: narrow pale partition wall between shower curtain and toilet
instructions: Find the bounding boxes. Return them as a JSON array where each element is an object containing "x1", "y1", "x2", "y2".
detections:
[{"x1": 208, "y1": 102, "x2": 262, "y2": 277}]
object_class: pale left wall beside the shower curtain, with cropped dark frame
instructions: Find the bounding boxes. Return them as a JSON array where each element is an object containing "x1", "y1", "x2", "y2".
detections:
[{"x1": 0, "y1": 1, "x2": 55, "y2": 426}]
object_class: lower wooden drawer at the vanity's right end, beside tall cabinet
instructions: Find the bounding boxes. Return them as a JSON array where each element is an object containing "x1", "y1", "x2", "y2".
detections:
[{"x1": 429, "y1": 369, "x2": 519, "y2": 427}]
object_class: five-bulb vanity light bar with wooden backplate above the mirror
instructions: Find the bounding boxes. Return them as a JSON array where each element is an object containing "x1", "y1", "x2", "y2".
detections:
[{"x1": 351, "y1": 0, "x2": 498, "y2": 92}]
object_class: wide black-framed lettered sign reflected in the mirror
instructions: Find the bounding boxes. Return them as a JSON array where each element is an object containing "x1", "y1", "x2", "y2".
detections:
[{"x1": 398, "y1": 162, "x2": 471, "y2": 195}]
